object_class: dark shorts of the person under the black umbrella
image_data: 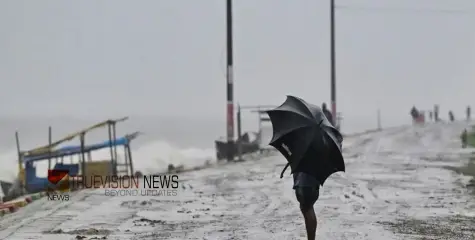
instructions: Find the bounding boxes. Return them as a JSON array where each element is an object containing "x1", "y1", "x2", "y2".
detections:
[{"x1": 293, "y1": 172, "x2": 320, "y2": 210}]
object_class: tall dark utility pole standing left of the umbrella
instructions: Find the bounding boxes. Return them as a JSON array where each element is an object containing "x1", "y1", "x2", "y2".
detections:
[{"x1": 226, "y1": 0, "x2": 235, "y2": 161}]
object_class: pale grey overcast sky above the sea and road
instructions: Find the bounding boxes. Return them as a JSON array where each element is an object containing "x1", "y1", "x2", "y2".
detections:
[{"x1": 0, "y1": 0, "x2": 475, "y2": 127}]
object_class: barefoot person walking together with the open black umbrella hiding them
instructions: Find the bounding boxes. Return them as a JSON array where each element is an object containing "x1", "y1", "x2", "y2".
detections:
[{"x1": 267, "y1": 96, "x2": 345, "y2": 240}]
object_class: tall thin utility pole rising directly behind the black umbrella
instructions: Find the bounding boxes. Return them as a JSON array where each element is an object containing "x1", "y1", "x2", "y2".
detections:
[{"x1": 330, "y1": 0, "x2": 337, "y2": 126}]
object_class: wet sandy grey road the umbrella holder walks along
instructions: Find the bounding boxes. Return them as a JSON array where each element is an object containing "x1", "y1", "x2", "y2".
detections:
[{"x1": 0, "y1": 124, "x2": 475, "y2": 240}]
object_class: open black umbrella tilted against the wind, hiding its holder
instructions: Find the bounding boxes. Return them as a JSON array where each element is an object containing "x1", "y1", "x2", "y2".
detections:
[{"x1": 267, "y1": 96, "x2": 345, "y2": 185}]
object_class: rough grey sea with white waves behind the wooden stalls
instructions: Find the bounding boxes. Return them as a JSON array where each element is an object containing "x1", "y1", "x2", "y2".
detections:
[{"x1": 0, "y1": 116, "x2": 396, "y2": 181}]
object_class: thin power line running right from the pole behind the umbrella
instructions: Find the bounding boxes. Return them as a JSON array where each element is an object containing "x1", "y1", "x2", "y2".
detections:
[{"x1": 335, "y1": 5, "x2": 475, "y2": 16}]
